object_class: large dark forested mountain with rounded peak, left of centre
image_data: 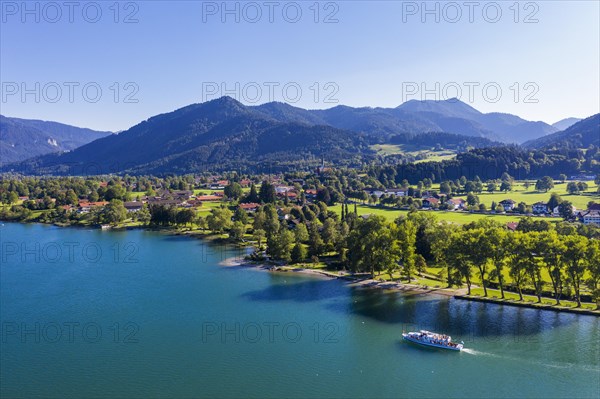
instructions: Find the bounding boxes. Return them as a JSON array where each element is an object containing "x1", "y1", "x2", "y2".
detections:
[{"x1": 7, "y1": 97, "x2": 372, "y2": 174}]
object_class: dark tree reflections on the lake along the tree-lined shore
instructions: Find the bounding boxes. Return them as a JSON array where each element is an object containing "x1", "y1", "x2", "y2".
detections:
[{"x1": 242, "y1": 274, "x2": 593, "y2": 342}]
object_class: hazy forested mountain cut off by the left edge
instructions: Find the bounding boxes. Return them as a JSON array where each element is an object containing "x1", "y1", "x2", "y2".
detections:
[{"x1": 0, "y1": 115, "x2": 111, "y2": 164}]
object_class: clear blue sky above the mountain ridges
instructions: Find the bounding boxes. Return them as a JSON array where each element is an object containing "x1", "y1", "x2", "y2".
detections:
[{"x1": 0, "y1": 1, "x2": 600, "y2": 131}]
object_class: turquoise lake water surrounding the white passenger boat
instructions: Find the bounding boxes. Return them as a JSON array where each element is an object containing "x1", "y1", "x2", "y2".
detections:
[{"x1": 0, "y1": 223, "x2": 600, "y2": 398}]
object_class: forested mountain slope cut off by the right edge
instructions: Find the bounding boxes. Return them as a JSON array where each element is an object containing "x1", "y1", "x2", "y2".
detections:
[{"x1": 523, "y1": 114, "x2": 600, "y2": 148}]
